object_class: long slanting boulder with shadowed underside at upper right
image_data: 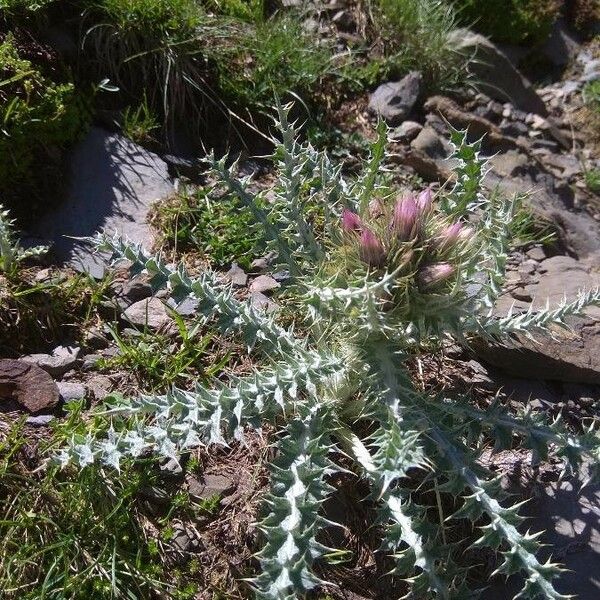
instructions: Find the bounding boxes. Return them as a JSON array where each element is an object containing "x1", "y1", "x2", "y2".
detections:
[{"x1": 451, "y1": 29, "x2": 548, "y2": 116}]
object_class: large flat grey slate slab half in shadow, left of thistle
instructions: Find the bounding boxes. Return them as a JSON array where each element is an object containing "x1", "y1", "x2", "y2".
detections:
[{"x1": 32, "y1": 127, "x2": 174, "y2": 277}]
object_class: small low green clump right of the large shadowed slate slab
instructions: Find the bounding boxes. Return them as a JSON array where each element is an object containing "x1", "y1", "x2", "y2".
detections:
[{"x1": 154, "y1": 187, "x2": 259, "y2": 268}]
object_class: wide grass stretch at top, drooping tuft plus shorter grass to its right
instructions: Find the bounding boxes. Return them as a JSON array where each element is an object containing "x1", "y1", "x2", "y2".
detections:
[{"x1": 82, "y1": 0, "x2": 332, "y2": 136}]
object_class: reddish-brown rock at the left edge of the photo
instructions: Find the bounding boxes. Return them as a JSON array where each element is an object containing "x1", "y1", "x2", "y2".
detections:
[{"x1": 0, "y1": 358, "x2": 59, "y2": 413}]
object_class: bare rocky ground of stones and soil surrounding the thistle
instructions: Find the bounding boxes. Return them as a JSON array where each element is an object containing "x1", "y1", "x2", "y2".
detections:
[{"x1": 0, "y1": 11, "x2": 600, "y2": 600}]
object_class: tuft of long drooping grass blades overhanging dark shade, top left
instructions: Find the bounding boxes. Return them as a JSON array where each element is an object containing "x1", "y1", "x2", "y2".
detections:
[{"x1": 82, "y1": 0, "x2": 220, "y2": 130}]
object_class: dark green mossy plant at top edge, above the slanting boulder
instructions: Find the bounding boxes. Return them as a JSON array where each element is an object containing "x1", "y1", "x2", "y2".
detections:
[{"x1": 454, "y1": 0, "x2": 562, "y2": 44}]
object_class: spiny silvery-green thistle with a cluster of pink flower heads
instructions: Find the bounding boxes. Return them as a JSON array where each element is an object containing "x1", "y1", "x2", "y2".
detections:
[{"x1": 56, "y1": 107, "x2": 600, "y2": 600}]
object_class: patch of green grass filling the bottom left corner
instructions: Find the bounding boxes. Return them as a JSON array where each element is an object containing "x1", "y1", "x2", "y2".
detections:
[{"x1": 0, "y1": 418, "x2": 166, "y2": 600}]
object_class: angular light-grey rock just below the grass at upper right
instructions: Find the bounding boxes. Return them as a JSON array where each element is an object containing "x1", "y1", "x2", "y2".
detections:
[{"x1": 369, "y1": 71, "x2": 423, "y2": 127}]
